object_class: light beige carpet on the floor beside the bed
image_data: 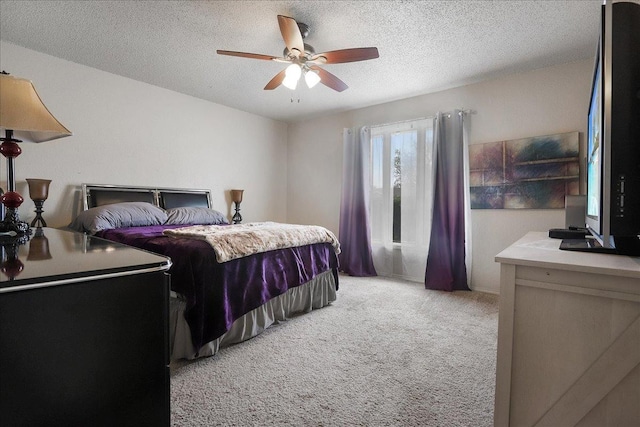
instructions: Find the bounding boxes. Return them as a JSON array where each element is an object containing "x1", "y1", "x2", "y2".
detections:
[{"x1": 171, "y1": 276, "x2": 498, "y2": 427}]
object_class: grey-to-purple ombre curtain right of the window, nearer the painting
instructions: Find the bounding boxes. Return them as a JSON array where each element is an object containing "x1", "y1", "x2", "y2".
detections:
[{"x1": 425, "y1": 111, "x2": 469, "y2": 291}]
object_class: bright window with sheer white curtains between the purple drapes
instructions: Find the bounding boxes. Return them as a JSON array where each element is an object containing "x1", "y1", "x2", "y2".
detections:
[{"x1": 370, "y1": 119, "x2": 433, "y2": 281}]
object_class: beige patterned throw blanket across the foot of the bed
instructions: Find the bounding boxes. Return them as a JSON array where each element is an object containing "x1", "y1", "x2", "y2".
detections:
[{"x1": 163, "y1": 222, "x2": 340, "y2": 262}]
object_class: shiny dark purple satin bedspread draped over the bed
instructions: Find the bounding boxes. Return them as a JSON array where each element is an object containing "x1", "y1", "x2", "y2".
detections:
[{"x1": 96, "y1": 225, "x2": 338, "y2": 348}]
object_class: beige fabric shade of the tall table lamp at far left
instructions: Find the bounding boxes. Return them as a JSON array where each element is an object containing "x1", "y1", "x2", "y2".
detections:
[{"x1": 0, "y1": 74, "x2": 71, "y2": 142}]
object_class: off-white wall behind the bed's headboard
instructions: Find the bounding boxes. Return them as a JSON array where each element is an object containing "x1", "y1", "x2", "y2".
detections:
[{"x1": 0, "y1": 42, "x2": 287, "y2": 227}]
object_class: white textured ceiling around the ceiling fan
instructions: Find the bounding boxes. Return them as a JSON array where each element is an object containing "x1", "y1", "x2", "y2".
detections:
[{"x1": 0, "y1": 0, "x2": 602, "y2": 122}]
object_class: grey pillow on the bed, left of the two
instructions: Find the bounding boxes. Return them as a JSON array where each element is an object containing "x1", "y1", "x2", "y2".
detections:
[{"x1": 69, "y1": 202, "x2": 167, "y2": 234}]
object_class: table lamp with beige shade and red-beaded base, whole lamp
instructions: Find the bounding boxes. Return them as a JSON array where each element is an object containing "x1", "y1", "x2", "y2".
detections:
[{"x1": 0, "y1": 71, "x2": 71, "y2": 239}]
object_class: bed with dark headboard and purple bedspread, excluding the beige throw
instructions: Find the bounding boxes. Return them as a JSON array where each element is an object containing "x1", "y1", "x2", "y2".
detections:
[{"x1": 69, "y1": 184, "x2": 339, "y2": 360}]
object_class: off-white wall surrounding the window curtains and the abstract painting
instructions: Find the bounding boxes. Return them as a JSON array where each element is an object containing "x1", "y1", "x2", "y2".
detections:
[{"x1": 287, "y1": 60, "x2": 593, "y2": 293}]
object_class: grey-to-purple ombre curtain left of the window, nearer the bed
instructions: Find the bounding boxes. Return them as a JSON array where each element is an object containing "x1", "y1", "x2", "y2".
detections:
[{"x1": 338, "y1": 127, "x2": 377, "y2": 276}]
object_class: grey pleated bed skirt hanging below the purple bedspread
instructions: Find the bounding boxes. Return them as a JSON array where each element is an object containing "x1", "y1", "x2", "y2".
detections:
[{"x1": 169, "y1": 270, "x2": 337, "y2": 360}]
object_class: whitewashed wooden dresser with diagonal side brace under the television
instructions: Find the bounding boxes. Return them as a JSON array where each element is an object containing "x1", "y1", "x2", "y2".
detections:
[{"x1": 494, "y1": 232, "x2": 640, "y2": 427}]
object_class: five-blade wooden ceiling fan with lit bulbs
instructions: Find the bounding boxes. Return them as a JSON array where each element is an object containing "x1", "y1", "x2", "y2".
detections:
[{"x1": 216, "y1": 15, "x2": 378, "y2": 92}]
